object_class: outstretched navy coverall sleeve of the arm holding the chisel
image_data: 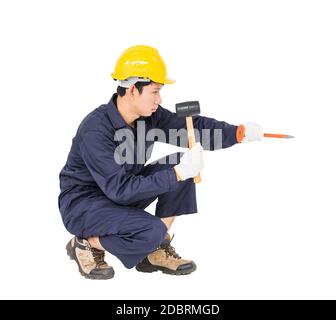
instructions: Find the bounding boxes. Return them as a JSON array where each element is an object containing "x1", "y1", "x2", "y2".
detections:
[{"x1": 155, "y1": 106, "x2": 238, "y2": 150}]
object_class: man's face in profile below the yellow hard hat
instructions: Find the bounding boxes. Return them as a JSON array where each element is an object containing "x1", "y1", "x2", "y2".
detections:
[{"x1": 134, "y1": 83, "x2": 163, "y2": 117}]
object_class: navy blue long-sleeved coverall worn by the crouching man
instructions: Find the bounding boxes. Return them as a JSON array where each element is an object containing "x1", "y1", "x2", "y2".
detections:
[{"x1": 58, "y1": 94, "x2": 237, "y2": 268}]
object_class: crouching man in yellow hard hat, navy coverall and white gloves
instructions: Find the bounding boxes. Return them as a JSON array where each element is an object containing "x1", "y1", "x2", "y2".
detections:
[{"x1": 59, "y1": 46, "x2": 263, "y2": 279}]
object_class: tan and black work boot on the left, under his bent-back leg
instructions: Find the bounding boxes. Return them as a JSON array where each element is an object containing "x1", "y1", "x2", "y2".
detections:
[{"x1": 66, "y1": 237, "x2": 114, "y2": 280}]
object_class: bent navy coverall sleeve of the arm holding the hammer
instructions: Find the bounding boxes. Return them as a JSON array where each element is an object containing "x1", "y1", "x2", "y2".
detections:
[{"x1": 80, "y1": 131, "x2": 178, "y2": 205}]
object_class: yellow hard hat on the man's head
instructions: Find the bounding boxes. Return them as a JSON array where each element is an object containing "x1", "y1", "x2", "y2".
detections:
[{"x1": 111, "y1": 45, "x2": 175, "y2": 84}]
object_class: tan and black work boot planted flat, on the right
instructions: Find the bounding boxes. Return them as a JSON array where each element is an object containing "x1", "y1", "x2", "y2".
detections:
[{"x1": 135, "y1": 233, "x2": 196, "y2": 275}]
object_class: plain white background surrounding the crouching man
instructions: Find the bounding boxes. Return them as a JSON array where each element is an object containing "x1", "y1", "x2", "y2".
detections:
[{"x1": 0, "y1": 0, "x2": 336, "y2": 299}]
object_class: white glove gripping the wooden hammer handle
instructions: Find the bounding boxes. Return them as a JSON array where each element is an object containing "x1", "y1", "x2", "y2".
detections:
[{"x1": 174, "y1": 142, "x2": 204, "y2": 180}]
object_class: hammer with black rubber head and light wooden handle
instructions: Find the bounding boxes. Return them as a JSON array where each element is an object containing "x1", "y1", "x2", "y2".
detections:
[{"x1": 175, "y1": 101, "x2": 201, "y2": 183}]
